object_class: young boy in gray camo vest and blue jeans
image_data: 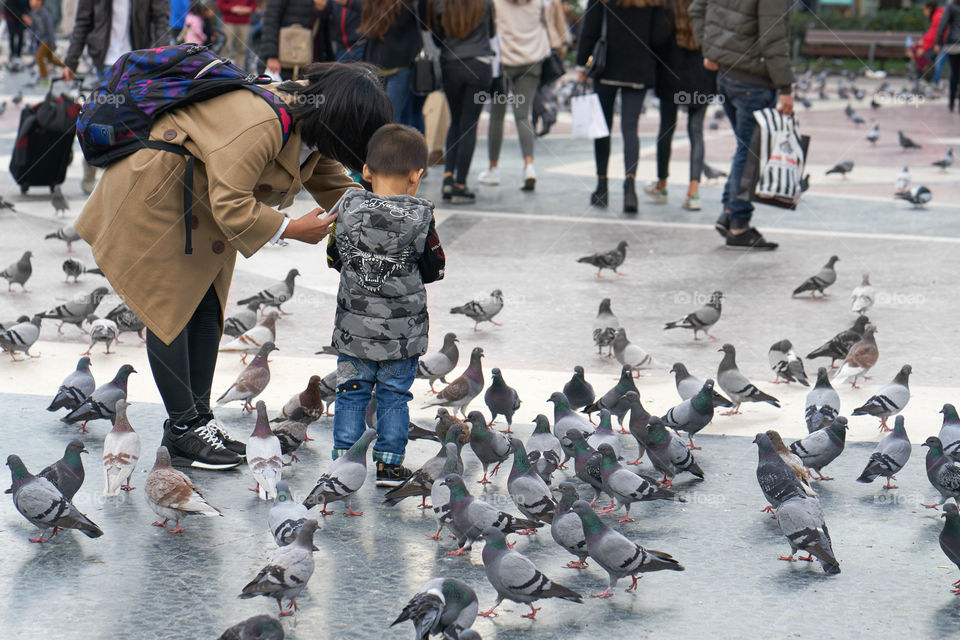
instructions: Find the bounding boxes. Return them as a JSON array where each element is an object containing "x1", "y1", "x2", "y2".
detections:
[{"x1": 327, "y1": 124, "x2": 445, "y2": 487}]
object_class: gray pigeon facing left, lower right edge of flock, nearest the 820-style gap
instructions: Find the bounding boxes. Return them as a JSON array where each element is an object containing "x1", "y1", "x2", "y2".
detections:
[{"x1": 573, "y1": 500, "x2": 684, "y2": 598}]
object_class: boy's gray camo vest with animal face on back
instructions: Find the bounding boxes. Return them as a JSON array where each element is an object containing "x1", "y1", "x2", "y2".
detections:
[{"x1": 333, "y1": 190, "x2": 433, "y2": 361}]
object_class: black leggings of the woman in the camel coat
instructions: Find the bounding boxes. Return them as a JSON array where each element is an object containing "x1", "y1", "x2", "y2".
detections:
[{"x1": 147, "y1": 285, "x2": 223, "y2": 425}]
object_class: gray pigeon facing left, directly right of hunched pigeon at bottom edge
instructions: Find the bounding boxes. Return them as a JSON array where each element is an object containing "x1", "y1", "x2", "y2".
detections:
[{"x1": 479, "y1": 527, "x2": 583, "y2": 620}]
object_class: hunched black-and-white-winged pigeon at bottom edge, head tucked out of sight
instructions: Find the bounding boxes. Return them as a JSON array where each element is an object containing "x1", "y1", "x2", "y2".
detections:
[{"x1": 390, "y1": 578, "x2": 479, "y2": 640}]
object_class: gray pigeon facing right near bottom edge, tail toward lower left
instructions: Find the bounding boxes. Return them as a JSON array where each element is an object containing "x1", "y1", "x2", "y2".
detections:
[{"x1": 239, "y1": 520, "x2": 319, "y2": 616}]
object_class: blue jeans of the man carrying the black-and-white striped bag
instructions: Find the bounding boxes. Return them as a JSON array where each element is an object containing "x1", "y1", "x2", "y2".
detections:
[{"x1": 717, "y1": 78, "x2": 777, "y2": 229}]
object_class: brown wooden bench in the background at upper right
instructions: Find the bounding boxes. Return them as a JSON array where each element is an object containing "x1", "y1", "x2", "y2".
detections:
[{"x1": 794, "y1": 29, "x2": 923, "y2": 67}]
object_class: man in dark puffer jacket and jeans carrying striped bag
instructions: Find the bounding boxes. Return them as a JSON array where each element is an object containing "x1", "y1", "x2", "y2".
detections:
[{"x1": 689, "y1": 0, "x2": 794, "y2": 250}]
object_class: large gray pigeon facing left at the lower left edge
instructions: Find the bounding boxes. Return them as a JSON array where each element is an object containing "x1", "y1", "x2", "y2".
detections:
[{"x1": 7, "y1": 455, "x2": 103, "y2": 543}]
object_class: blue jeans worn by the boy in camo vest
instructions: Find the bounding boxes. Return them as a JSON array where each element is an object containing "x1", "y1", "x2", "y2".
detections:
[{"x1": 333, "y1": 354, "x2": 420, "y2": 464}]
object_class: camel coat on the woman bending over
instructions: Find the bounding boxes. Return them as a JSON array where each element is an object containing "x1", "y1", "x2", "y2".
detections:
[{"x1": 75, "y1": 89, "x2": 358, "y2": 344}]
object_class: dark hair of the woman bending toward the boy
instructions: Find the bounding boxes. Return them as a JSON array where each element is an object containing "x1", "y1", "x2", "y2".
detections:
[{"x1": 279, "y1": 62, "x2": 393, "y2": 172}]
